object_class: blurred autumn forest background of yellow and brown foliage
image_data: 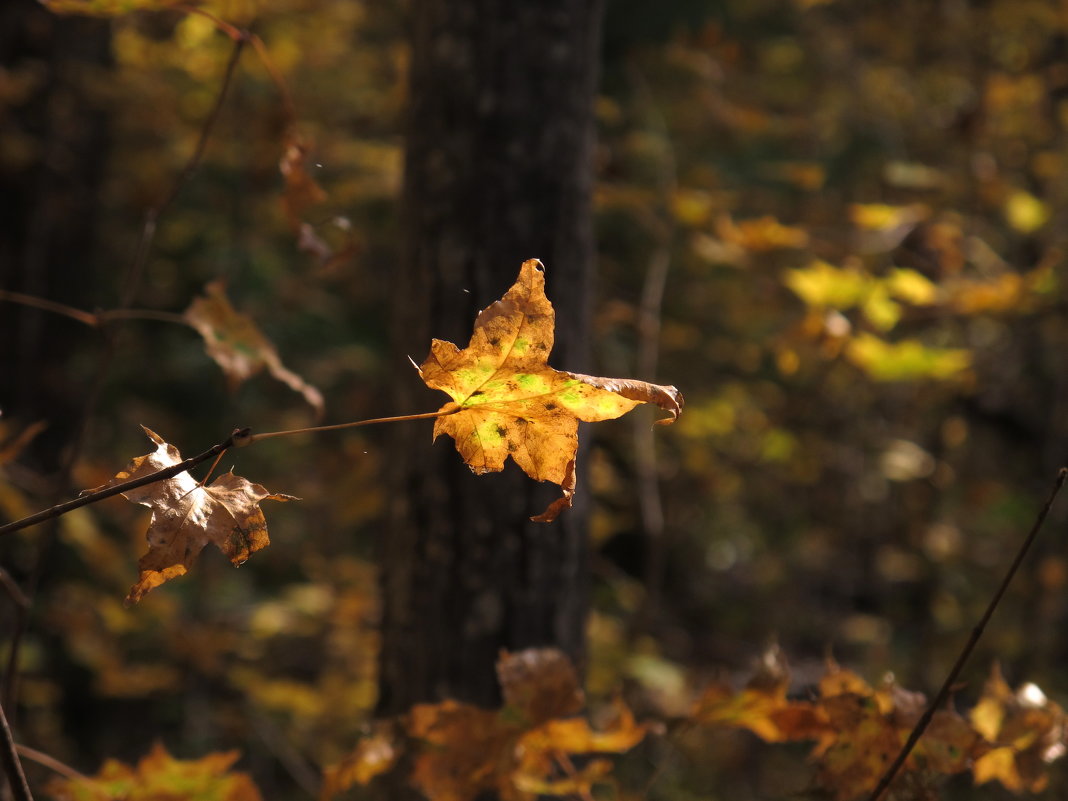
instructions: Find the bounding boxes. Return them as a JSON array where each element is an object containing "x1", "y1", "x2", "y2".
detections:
[{"x1": 0, "y1": 0, "x2": 1068, "y2": 799}]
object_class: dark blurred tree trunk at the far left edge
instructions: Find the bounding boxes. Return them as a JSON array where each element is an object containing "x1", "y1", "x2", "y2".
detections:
[{"x1": 0, "y1": 0, "x2": 110, "y2": 473}]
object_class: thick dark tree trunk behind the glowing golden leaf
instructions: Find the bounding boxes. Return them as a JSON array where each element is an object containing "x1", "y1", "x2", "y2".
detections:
[{"x1": 379, "y1": 0, "x2": 602, "y2": 714}]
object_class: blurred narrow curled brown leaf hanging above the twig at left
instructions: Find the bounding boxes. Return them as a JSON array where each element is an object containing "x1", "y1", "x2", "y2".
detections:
[{"x1": 184, "y1": 281, "x2": 324, "y2": 415}]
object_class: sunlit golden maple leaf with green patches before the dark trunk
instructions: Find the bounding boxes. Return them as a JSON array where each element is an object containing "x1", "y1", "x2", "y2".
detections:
[{"x1": 419, "y1": 258, "x2": 682, "y2": 522}]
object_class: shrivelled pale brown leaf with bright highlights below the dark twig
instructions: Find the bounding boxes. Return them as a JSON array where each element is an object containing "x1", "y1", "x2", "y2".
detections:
[{"x1": 96, "y1": 426, "x2": 298, "y2": 603}]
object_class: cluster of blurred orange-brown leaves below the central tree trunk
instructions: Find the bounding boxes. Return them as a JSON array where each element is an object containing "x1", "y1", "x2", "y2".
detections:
[{"x1": 320, "y1": 648, "x2": 648, "y2": 801}]
